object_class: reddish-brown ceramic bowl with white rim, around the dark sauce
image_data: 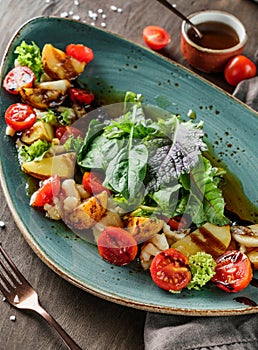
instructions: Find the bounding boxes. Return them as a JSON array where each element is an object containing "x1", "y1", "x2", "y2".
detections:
[{"x1": 181, "y1": 10, "x2": 247, "y2": 73}]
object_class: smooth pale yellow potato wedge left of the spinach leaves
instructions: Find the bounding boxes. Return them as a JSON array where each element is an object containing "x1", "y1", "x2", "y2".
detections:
[{"x1": 22, "y1": 152, "x2": 76, "y2": 180}]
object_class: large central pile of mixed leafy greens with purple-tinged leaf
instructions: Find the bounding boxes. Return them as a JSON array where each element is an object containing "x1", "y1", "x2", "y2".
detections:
[{"x1": 78, "y1": 92, "x2": 228, "y2": 226}]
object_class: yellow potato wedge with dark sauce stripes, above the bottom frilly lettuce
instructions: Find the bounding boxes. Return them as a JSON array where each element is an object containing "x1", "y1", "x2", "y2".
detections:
[{"x1": 172, "y1": 223, "x2": 231, "y2": 258}]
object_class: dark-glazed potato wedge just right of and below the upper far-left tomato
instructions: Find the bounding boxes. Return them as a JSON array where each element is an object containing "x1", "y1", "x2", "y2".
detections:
[{"x1": 20, "y1": 80, "x2": 71, "y2": 109}]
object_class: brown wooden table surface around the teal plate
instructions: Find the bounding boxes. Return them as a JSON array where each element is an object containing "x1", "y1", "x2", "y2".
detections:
[{"x1": 0, "y1": 0, "x2": 258, "y2": 350}]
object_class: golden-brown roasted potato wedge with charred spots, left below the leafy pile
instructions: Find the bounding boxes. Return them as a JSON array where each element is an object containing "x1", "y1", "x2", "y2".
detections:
[{"x1": 63, "y1": 191, "x2": 108, "y2": 230}]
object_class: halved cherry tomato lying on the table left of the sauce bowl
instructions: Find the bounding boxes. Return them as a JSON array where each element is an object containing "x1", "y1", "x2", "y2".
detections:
[{"x1": 143, "y1": 26, "x2": 170, "y2": 50}]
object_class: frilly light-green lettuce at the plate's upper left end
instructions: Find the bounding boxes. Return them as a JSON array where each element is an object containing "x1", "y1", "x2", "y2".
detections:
[{"x1": 14, "y1": 40, "x2": 44, "y2": 81}]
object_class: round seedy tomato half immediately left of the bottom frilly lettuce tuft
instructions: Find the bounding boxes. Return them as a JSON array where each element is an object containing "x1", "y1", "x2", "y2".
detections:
[{"x1": 150, "y1": 248, "x2": 192, "y2": 291}]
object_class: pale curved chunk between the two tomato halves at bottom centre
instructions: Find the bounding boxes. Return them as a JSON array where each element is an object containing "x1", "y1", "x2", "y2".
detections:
[{"x1": 140, "y1": 233, "x2": 169, "y2": 270}]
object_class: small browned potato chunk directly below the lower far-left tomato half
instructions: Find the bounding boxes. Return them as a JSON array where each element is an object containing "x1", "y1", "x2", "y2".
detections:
[{"x1": 21, "y1": 121, "x2": 54, "y2": 145}]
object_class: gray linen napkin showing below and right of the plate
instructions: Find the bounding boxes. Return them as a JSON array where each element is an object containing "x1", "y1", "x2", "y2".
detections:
[{"x1": 144, "y1": 69, "x2": 258, "y2": 350}]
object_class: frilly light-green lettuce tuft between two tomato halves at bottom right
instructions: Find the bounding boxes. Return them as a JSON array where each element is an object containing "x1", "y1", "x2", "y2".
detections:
[{"x1": 186, "y1": 252, "x2": 216, "y2": 290}]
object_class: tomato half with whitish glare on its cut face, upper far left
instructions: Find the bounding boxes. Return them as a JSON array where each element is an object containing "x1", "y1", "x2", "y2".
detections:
[{"x1": 3, "y1": 66, "x2": 36, "y2": 95}]
